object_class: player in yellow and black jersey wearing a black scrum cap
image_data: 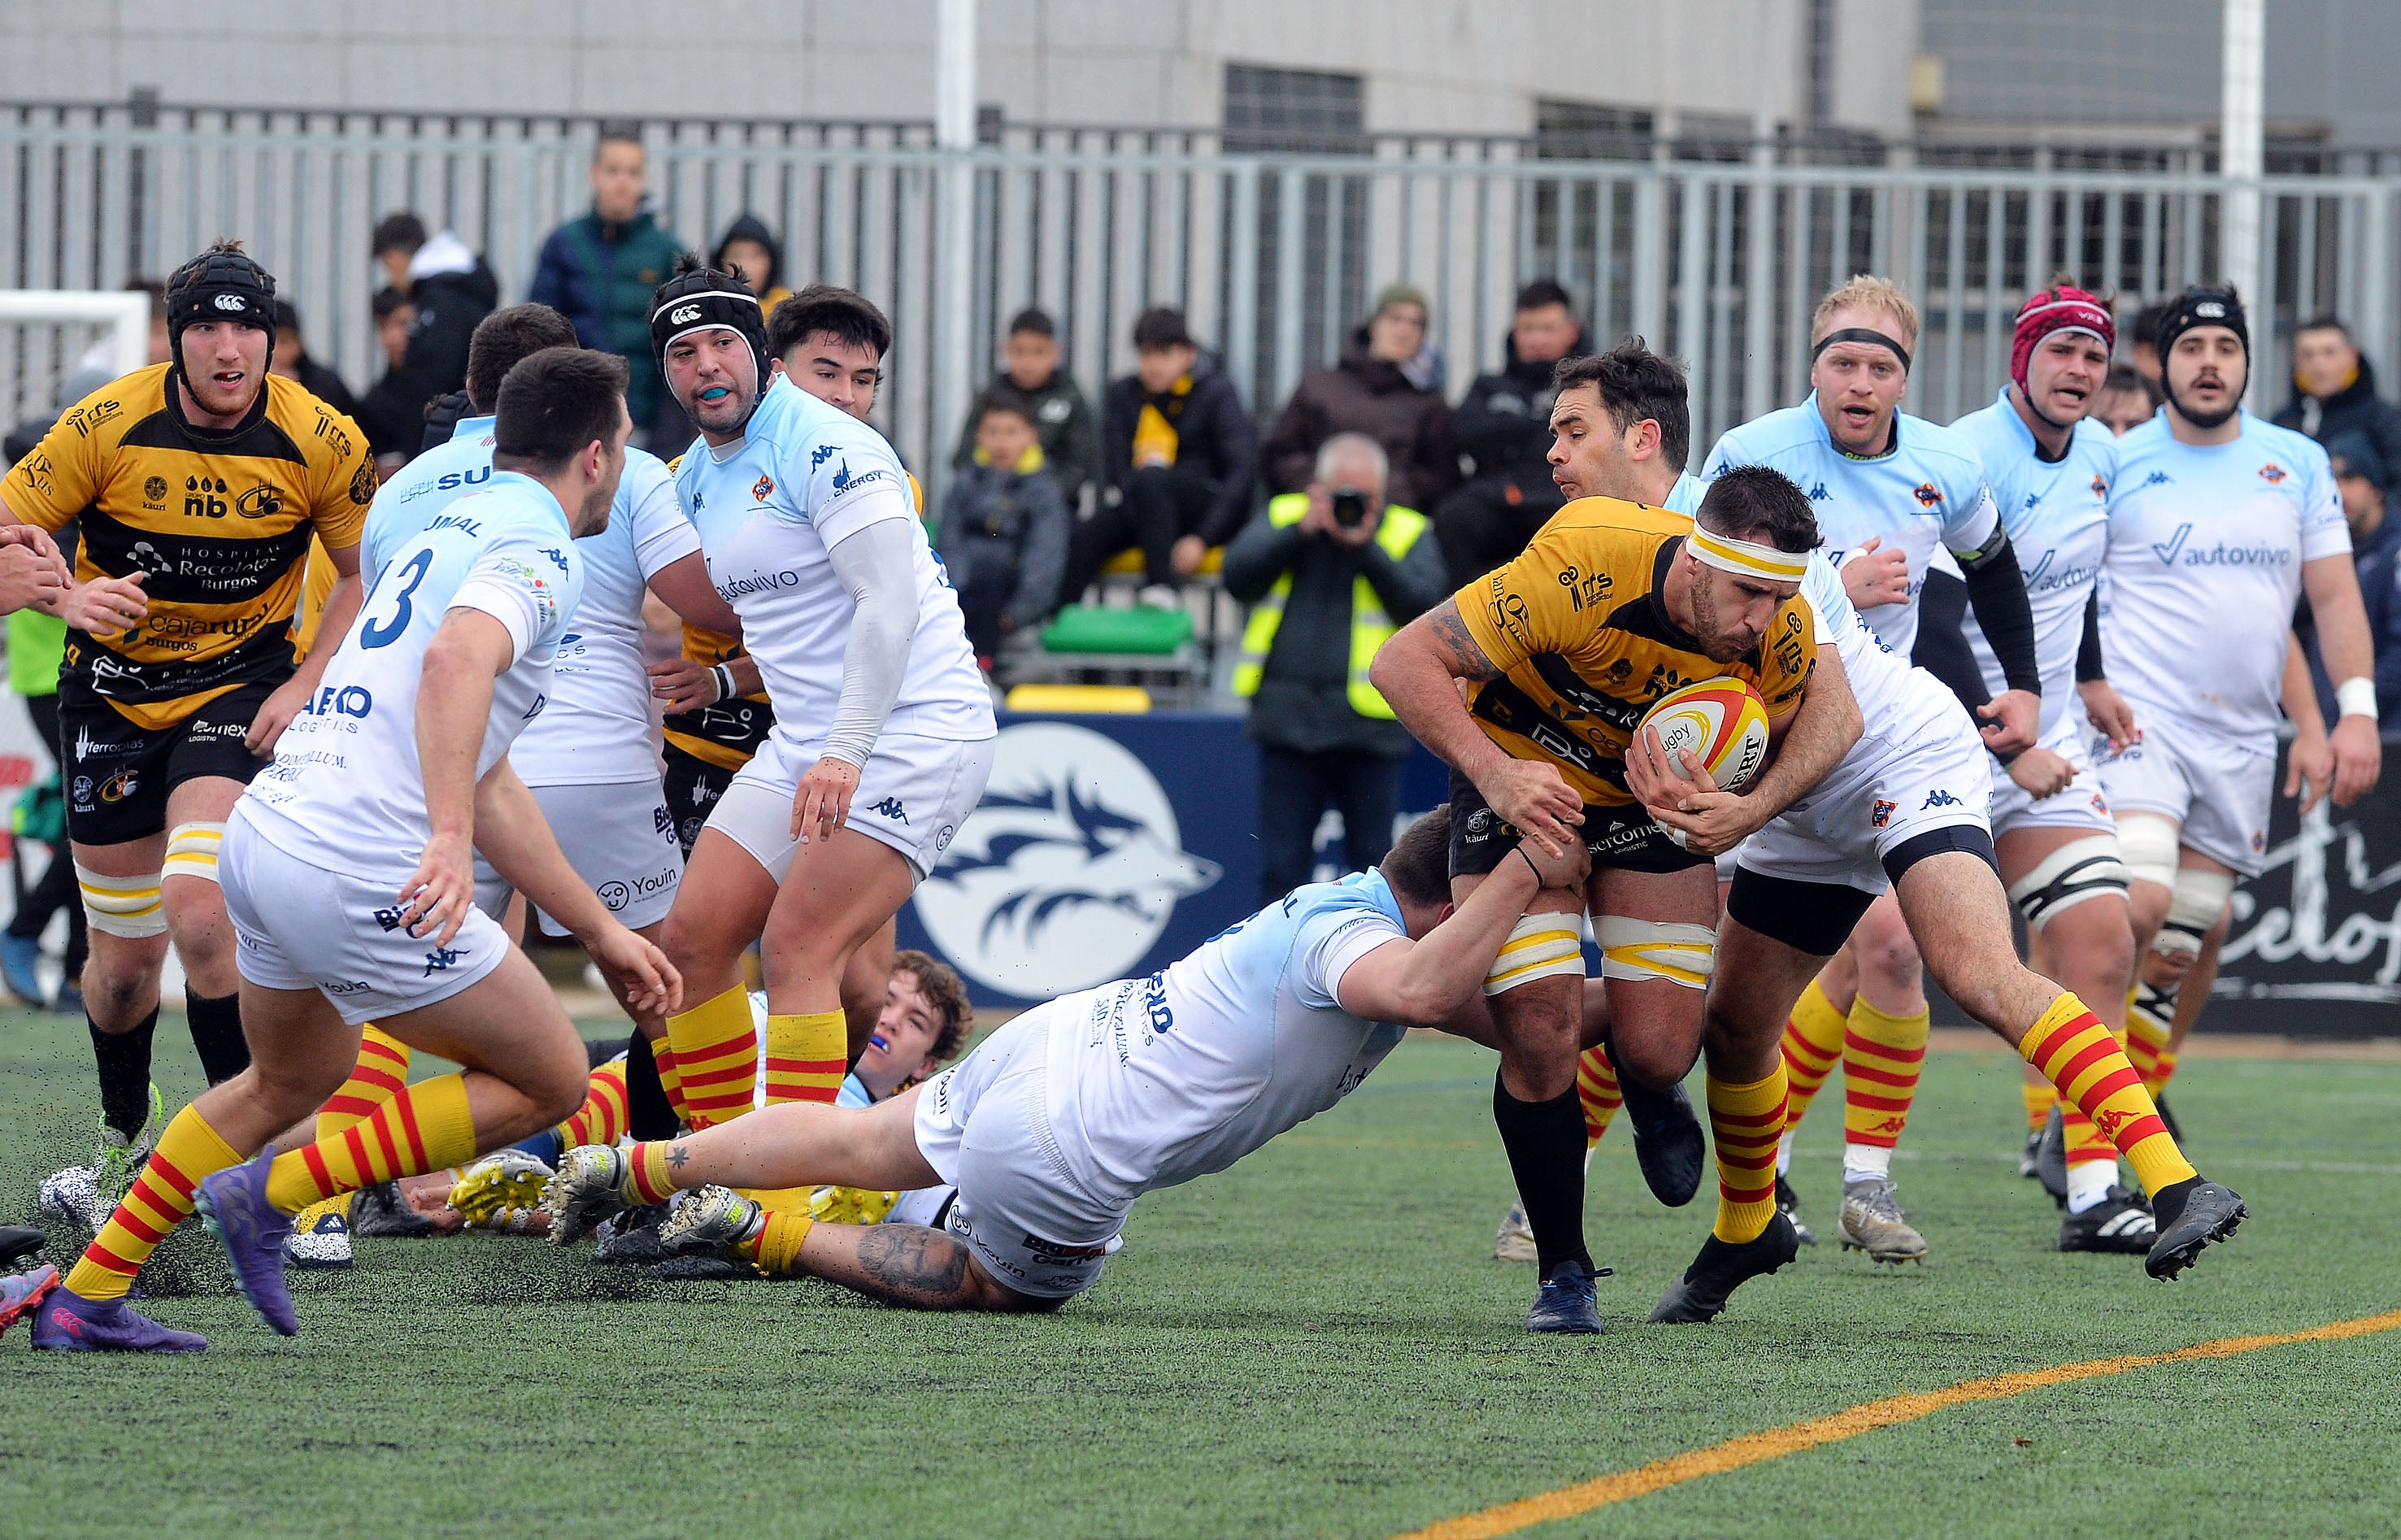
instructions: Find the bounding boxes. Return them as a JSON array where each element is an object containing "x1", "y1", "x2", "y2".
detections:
[{"x1": 0, "y1": 240, "x2": 375, "y2": 1213}]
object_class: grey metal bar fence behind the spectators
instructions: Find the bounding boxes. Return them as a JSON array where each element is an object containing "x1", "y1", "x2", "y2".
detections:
[{"x1": 0, "y1": 108, "x2": 2401, "y2": 478}]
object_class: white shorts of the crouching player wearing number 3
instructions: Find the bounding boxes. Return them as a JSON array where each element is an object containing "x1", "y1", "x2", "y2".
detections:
[{"x1": 216, "y1": 803, "x2": 509, "y2": 1026}]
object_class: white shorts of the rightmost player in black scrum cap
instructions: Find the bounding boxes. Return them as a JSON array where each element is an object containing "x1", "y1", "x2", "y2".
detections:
[{"x1": 2094, "y1": 702, "x2": 2276, "y2": 877}]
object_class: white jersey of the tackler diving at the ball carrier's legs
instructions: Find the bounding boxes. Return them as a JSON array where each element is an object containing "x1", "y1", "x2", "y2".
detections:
[{"x1": 1045, "y1": 872, "x2": 1407, "y2": 1203}]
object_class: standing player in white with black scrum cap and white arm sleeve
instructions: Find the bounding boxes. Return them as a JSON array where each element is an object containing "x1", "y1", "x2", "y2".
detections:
[{"x1": 650, "y1": 262, "x2": 996, "y2": 1153}]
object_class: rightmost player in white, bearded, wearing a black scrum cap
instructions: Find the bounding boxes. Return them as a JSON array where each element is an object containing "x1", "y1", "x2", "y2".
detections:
[{"x1": 2096, "y1": 286, "x2": 2381, "y2": 1086}]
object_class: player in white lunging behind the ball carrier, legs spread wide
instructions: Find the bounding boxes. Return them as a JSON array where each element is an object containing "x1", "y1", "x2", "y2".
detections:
[{"x1": 1633, "y1": 355, "x2": 2242, "y2": 1321}]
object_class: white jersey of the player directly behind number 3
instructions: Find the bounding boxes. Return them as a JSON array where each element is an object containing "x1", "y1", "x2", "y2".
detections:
[{"x1": 360, "y1": 418, "x2": 701, "y2": 785}]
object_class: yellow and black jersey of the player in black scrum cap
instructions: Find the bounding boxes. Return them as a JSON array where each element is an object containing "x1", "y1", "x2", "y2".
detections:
[{"x1": 0, "y1": 363, "x2": 375, "y2": 730}]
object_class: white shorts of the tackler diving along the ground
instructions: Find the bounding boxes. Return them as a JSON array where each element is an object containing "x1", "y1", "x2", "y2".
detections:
[{"x1": 917, "y1": 994, "x2": 1131, "y2": 1300}]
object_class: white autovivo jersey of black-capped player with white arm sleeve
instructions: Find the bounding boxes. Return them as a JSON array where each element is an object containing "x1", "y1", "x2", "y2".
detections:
[{"x1": 675, "y1": 375, "x2": 994, "y2": 759}]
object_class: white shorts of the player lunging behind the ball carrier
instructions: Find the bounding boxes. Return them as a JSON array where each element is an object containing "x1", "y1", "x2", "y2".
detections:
[{"x1": 1736, "y1": 699, "x2": 1993, "y2": 894}]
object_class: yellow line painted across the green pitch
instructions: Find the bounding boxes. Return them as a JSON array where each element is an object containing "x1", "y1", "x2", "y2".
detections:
[{"x1": 1395, "y1": 1309, "x2": 2401, "y2": 1540}]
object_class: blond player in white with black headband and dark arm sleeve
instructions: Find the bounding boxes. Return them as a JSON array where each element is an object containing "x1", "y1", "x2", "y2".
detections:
[{"x1": 1707, "y1": 276, "x2": 2041, "y2": 1261}]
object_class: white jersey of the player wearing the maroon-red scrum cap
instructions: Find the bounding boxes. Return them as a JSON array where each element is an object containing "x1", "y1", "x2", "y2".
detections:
[{"x1": 1952, "y1": 389, "x2": 2118, "y2": 740}]
